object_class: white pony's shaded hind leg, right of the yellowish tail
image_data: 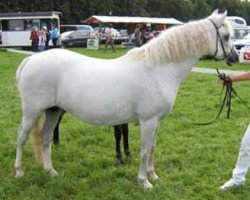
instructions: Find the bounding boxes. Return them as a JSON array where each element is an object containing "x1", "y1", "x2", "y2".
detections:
[{"x1": 42, "y1": 107, "x2": 61, "y2": 176}]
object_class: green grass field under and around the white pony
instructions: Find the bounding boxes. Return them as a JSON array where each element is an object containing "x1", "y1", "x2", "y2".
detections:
[{"x1": 0, "y1": 48, "x2": 250, "y2": 200}]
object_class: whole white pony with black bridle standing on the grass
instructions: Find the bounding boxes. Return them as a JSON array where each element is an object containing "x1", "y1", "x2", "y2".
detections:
[{"x1": 15, "y1": 11, "x2": 237, "y2": 189}]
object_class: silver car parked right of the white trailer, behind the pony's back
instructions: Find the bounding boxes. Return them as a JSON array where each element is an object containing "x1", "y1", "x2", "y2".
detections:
[{"x1": 61, "y1": 29, "x2": 95, "y2": 47}]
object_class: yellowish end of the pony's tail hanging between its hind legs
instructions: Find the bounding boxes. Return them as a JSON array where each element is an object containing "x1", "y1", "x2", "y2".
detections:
[{"x1": 31, "y1": 118, "x2": 43, "y2": 164}]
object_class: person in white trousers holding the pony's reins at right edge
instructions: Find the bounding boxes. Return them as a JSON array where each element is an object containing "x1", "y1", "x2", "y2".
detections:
[{"x1": 220, "y1": 72, "x2": 250, "y2": 190}]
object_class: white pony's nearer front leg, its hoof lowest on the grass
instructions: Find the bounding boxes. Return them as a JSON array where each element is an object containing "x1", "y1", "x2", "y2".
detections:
[{"x1": 138, "y1": 118, "x2": 158, "y2": 189}]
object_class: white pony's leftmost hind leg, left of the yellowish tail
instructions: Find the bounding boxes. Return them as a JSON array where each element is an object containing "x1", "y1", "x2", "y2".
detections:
[{"x1": 15, "y1": 113, "x2": 39, "y2": 178}]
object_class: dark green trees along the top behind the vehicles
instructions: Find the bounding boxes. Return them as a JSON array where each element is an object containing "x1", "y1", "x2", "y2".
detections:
[{"x1": 0, "y1": 0, "x2": 250, "y2": 24}]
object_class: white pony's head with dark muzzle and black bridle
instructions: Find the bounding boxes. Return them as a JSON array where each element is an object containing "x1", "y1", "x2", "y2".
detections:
[{"x1": 208, "y1": 10, "x2": 238, "y2": 65}]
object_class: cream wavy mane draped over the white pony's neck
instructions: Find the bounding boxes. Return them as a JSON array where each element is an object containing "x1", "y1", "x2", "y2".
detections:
[{"x1": 128, "y1": 19, "x2": 215, "y2": 66}]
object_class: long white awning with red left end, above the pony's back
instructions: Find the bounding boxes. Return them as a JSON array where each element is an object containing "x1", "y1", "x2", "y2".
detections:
[{"x1": 84, "y1": 15, "x2": 183, "y2": 25}]
